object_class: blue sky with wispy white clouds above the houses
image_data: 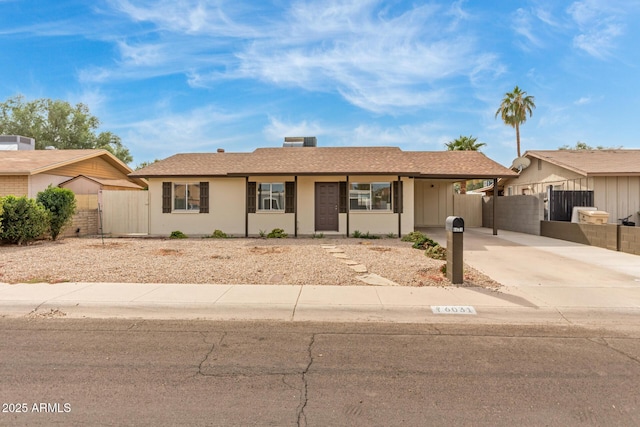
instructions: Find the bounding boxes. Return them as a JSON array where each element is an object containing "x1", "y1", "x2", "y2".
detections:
[{"x1": 0, "y1": 0, "x2": 640, "y2": 166}]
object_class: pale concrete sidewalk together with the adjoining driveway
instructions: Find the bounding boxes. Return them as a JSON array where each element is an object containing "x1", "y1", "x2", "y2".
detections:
[{"x1": 0, "y1": 229, "x2": 640, "y2": 327}]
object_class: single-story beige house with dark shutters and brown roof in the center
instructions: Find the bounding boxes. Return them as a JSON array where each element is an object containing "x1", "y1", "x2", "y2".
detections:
[{"x1": 129, "y1": 145, "x2": 517, "y2": 236}]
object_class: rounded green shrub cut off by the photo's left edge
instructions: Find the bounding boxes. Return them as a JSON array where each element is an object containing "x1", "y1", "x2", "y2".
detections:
[{"x1": 0, "y1": 196, "x2": 50, "y2": 245}]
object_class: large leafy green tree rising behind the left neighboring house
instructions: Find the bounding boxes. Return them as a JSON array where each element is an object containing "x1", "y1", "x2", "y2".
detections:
[{"x1": 0, "y1": 95, "x2": 133, "y2": 163}]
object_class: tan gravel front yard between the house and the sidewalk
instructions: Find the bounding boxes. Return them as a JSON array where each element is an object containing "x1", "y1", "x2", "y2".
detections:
[{"x1": 0, "y1": 238, "x2": 500, "y2": 288}]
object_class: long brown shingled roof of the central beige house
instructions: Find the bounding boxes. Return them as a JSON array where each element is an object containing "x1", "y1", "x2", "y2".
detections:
[{"x1": 129, "y1": 147, "x2": 517, "y2": 178}]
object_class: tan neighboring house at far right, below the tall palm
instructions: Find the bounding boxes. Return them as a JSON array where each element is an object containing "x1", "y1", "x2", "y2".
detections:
[{"x1": 499, "y1": 150, "x2": 640, "y2": 224}]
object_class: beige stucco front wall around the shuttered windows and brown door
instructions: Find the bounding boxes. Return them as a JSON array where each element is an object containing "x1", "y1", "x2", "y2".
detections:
[{"x1": 149, "y1": 175, "x2": 416, "y2": 236}]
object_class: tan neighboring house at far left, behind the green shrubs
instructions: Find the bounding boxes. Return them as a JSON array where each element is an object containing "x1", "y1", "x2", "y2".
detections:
[{"x1": 0, "y1": 142, "x2": 147, "y2": 198}]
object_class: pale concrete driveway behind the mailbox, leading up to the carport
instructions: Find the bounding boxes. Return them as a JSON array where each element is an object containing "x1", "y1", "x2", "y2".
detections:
[{"x1": 423, "y1": 228, "x2": 640, "y2": 308}]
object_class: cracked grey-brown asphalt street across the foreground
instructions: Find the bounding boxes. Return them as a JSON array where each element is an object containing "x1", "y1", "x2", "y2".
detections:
[{"x1": 0, "y1": 318, "x2": 640, "y2": 426}]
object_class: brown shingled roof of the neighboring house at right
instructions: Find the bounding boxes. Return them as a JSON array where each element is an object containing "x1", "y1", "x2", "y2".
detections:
[{"x1": 524, "y1": 150, "x2": 640, "y2": 176}]
